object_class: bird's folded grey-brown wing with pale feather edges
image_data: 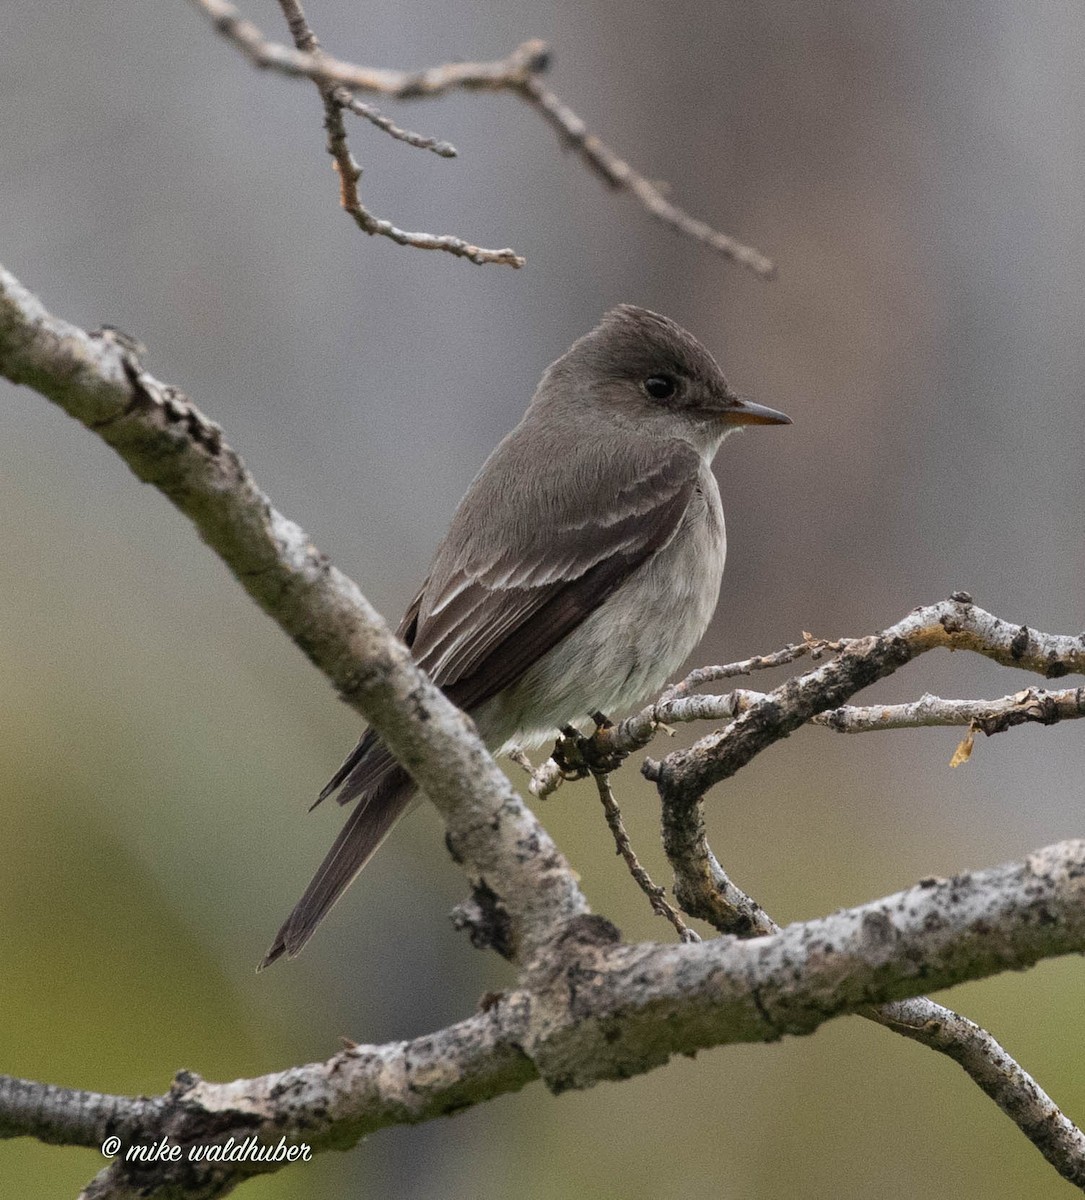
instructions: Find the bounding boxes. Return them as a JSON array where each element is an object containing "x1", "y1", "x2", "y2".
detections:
[{"x1": 317, "y1": 442, "x2": 700, "y2": 804}]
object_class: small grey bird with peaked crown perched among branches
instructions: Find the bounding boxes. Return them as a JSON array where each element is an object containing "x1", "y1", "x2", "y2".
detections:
[{"x1": 262, "y1": 305, "x2": 790, "y2": 966}]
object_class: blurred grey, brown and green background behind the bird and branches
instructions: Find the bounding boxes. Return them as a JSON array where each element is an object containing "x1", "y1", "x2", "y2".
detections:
[{"x1": 0, "y1": 0, "x2": 1085, "y2": 1200}]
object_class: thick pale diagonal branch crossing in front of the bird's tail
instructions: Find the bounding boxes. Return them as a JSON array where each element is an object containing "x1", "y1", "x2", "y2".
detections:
[{"x1": 0, "y1": 268, "x2": 587, "y2": 958}]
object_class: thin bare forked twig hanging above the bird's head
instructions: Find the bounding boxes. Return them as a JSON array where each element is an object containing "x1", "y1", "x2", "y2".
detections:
[{"x1": 192, "y1": 0, "x2": 775, "y2": 278}]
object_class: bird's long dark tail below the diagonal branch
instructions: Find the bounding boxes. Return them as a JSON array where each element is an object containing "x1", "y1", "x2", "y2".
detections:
[{"x1": 260, "y1": 743, "x2": 414, "y2": 970}]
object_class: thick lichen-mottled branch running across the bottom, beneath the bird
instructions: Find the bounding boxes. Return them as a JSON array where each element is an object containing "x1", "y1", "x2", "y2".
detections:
[{"x1": 0, "y1": 841, "x2": 1085, "y2": 1200}]
